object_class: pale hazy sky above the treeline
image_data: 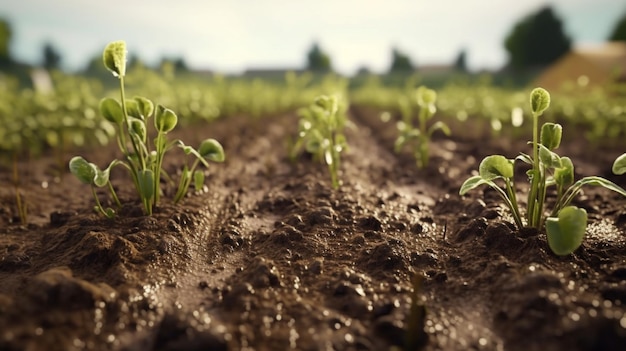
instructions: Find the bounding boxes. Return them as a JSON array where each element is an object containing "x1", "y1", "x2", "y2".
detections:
[{"x1": 0, "y1": 0, "x2": 626, "y2": 75}]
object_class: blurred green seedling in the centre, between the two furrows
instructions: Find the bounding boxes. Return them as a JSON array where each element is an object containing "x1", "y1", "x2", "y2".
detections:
[{"x1": 290, "y1": 95, "x2": 348, "y2": 189}]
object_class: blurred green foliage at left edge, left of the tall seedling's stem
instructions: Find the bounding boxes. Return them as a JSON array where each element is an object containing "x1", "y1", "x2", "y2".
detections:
[{"x1": 0, "y1": 72, "x2": 115, "y2": 157}]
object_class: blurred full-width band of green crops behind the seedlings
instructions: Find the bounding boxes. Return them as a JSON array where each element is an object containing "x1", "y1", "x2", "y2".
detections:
[{"x1": 0, "y1": 67, "x2": 626, "y2": 161}]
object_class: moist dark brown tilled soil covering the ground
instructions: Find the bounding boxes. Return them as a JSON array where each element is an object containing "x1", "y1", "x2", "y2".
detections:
[{"x1": 0, "y1": 108, "x2": 626, "y2": 350}]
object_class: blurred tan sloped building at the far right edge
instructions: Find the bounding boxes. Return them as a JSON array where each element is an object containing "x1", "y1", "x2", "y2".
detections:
[{"x1": 534, "y1": 42, "x2": 626, "y2": 90}]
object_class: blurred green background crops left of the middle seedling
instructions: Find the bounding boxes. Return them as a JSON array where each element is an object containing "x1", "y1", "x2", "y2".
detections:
[{"x1": 0, "y1": 68, "x2": 347, "y2": 159}]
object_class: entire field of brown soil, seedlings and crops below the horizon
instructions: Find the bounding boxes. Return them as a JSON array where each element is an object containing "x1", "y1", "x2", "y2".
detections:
[{"x1": 0, "y1": 42, "x2": 626, "y2": 351}]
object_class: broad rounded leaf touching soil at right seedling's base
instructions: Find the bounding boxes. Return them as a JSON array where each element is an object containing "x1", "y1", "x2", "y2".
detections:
[{"x1": 546, "y1": 206, "x2": 587, "y2": 256}]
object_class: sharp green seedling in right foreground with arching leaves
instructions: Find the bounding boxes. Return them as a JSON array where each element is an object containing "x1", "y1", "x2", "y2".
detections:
[{"x1": 459, "y1": 88, "x2": 626, "y2": 255}]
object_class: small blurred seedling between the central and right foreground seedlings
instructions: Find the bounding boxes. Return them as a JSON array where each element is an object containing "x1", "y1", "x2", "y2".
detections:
[{"x1": 395, "y1": 86, "x2": 450, "y2": 168}]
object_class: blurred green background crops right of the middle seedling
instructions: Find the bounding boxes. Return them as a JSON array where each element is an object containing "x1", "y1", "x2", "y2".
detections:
[{"x1": 350, "y1": 76, "x2": 626, "y2": 142}]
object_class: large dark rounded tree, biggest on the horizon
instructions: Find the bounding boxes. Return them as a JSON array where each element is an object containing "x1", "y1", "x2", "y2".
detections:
[{"x1": 504, "y1": 6, "x2": 571, "y2": 69}]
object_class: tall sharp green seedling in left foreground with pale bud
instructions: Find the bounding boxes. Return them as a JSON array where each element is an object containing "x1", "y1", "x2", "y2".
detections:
[{"x1": 69, "y1": 41, "x2": 224, "y2": 218}]
